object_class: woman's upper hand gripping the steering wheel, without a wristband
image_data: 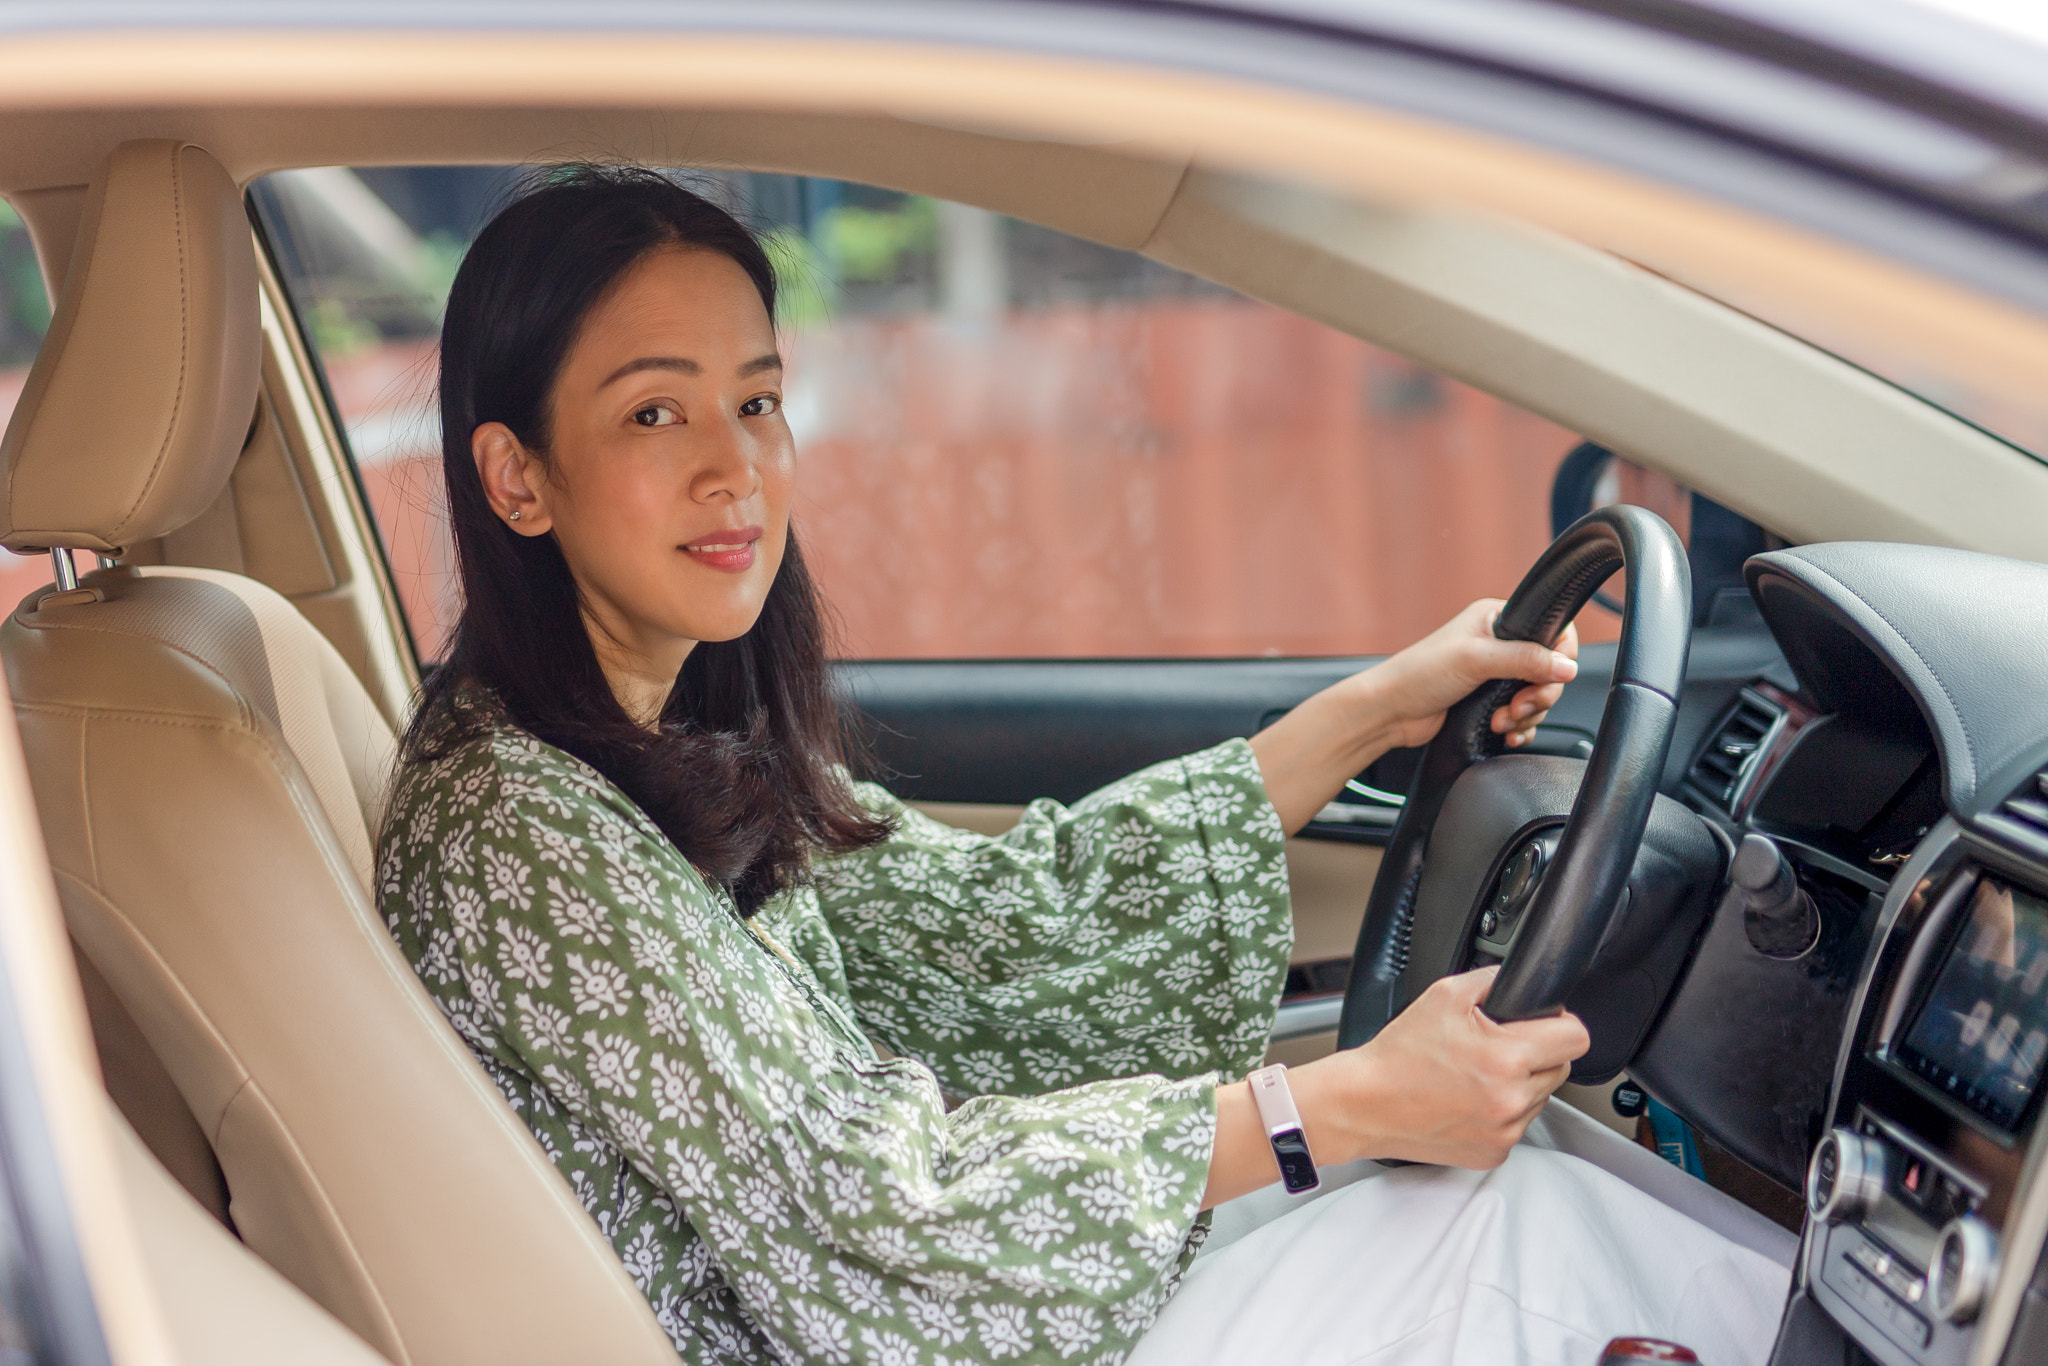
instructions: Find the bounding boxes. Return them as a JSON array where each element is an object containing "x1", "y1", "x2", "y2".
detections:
[{"x1": 1352, "y1": 598, "x2": 1579, "y2": 750}]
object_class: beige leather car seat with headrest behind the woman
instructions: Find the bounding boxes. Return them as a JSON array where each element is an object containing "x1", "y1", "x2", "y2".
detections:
[{"x1": 0, "y1": 141, "x2": 676, "y2": 1366}]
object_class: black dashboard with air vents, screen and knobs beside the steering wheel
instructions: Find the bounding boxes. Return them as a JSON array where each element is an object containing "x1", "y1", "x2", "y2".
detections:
[{"x1": 1630, "y1": 545, "x2": 2048, "y2": 1366}]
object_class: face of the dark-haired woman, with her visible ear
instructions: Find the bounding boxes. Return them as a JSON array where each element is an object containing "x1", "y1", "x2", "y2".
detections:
[{"x1": 473, "y1": 248, "x2": 797, "y2": 694}]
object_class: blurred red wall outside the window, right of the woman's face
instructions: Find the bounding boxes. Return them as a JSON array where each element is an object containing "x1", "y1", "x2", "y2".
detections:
[{"x1": 793, "y1": 301, "x2": 1605, "y2": 657}]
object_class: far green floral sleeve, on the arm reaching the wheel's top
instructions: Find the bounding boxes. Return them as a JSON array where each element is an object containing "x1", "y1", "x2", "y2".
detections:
[{"x1": 819, "y1": 739, "x2": 1294, "y2": 1096}]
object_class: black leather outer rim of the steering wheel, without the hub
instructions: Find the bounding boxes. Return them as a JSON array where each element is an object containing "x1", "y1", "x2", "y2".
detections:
[{"x1": 1337, "y1": 504, "x2": 1692, "y2": 1049}]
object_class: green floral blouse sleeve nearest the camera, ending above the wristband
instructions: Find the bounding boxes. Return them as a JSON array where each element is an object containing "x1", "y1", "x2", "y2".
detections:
[{"x1": 395, "y1": 741, "x2": 1219, "y2": 1366}]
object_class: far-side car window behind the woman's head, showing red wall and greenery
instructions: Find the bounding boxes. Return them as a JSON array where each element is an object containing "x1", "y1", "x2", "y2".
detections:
[{"x1": 252, "y1": 168, "x2": 1614, "y2": 661}]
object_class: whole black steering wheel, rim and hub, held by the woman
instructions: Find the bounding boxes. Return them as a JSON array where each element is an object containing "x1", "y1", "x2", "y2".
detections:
[{"x1": 1337, "y1": 504, "x2": 1692, "y2": 1049}]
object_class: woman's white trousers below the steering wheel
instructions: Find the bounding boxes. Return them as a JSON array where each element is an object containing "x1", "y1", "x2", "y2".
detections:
[{"x1": 1128, "y1": 1147, "x2": 1788, "y2": 1366}]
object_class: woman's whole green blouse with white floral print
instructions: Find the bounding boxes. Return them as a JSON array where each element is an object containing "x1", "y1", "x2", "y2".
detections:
[{"x1": 377, "y1": 729, "x2": 1292, "y2": 1366}]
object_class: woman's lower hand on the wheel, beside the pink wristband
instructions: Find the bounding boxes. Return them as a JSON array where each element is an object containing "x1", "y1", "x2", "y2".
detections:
[{"x1": 1305, "y1": 967, "x2": 1591, "y2": 1169}]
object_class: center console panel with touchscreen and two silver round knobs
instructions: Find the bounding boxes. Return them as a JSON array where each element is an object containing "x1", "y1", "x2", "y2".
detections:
[{"x1": 1802, "y1": 831, "x2": 2048, "y2": 1366}]
